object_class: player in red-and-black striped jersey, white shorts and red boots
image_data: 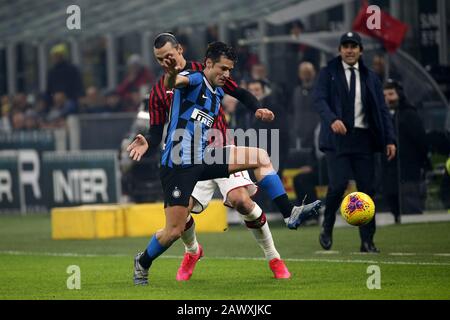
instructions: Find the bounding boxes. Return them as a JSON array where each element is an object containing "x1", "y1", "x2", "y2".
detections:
[{"x1": 128, "y1": 33, "x2": 318, "y2": 281}]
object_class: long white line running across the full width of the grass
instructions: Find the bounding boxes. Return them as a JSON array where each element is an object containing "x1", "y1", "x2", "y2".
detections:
[{"x1": 0, "y1": 251, "x2": 450, "y2": 266}]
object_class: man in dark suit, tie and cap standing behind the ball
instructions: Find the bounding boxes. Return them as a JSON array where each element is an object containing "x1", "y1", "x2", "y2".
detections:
[{"x1": 314, "y1": 32, "x2": 396, "y2": 252}]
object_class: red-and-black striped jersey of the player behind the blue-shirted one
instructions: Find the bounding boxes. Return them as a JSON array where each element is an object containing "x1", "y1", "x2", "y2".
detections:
[{"x1": 148, "y1": 61, "x2": 238, "y2": 145}]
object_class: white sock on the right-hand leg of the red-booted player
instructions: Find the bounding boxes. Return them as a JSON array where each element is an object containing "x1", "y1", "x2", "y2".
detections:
[{"x1": 241, "y1": 204, "x2": 280, "y2": 261}]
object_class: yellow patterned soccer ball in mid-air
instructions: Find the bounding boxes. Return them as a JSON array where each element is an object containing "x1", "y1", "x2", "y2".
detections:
[{"x1": 341, "y1": 192, "x2": 375, "y2": 226}]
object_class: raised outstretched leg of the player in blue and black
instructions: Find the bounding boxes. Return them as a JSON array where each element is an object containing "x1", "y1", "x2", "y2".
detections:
[{"x1": 228, "y1": 147, "x2": 322, "y2": 229}]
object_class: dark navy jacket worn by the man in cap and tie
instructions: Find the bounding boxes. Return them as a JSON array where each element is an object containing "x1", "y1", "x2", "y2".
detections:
[{"x1": 314, "y1": 57, "x2": 395, "y2": 152}]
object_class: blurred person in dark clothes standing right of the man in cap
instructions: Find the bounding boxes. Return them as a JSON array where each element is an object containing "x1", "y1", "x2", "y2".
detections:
[{"x1": 383, "y1": 80, "x2": 429, "y2": 223}]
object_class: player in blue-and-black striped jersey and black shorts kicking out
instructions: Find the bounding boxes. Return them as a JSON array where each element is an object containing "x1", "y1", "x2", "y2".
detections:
[{"x1": 130, "y1": 37, "x2": 320, "y2": 284}]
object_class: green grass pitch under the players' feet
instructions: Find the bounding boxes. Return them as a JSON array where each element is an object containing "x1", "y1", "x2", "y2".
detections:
[{"x1": 0, "y1": 215, "x2": 450, "y2": 300}]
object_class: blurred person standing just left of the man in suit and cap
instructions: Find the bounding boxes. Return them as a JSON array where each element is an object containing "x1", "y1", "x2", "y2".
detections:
[{"x1": 290, "y1": 62, "x2": 320, "y2": 149}]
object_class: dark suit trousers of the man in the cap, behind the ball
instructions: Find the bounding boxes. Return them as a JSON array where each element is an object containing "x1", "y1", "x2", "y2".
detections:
[{"x1": 322, "y1": 129, "x2": 376, "y2": 242}]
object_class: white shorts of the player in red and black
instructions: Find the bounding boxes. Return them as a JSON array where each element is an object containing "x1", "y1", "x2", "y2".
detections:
[{"x1": 191, "y1": 171, "x2": 258, "y2": 213}]
